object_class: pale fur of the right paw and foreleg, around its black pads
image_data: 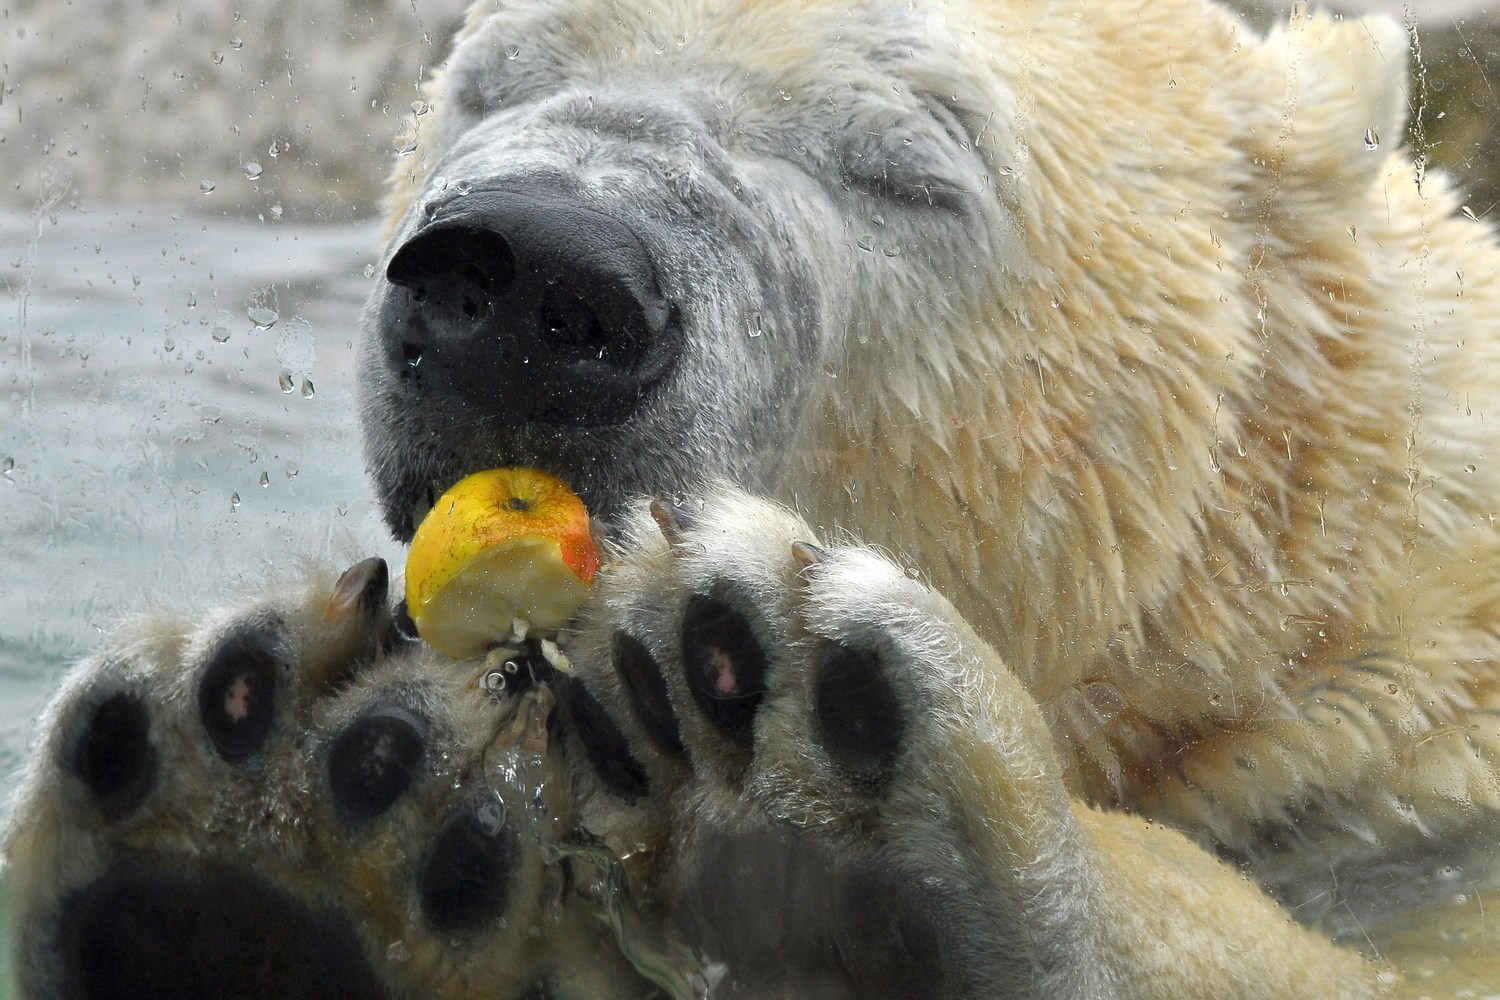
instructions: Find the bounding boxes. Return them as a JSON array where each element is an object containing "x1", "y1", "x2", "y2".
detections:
[{"x1": 575, "y1": 490, "x2": 1395, "y2": 1000}]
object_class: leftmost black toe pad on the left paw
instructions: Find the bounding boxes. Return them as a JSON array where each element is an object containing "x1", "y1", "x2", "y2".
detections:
[{"x1": 66, "y1": 691, "x2": 156, "y2": 819}]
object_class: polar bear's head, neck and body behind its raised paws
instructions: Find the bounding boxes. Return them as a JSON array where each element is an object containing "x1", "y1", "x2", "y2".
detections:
[{"x1": 363, "y1": 0, "x2": 1500, "y2": 919}]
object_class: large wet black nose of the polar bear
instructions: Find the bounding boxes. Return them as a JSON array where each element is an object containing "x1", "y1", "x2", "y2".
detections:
[{"x1": 383, "y1": 190, "x2": 681, "y2": 426}]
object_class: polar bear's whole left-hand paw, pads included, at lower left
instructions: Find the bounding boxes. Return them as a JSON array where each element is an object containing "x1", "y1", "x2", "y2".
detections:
[{"x1": 8, "y1": 559, "x2": 641, "y2": 1000}]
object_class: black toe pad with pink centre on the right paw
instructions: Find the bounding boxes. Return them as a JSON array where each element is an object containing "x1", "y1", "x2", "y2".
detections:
[{"x1": 683, "y1": 594, "x2": 767, "y2": 747}]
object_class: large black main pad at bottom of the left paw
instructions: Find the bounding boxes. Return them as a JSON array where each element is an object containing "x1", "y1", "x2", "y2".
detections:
[{"x1": 54, "y1": 864, "x2": 393, "y2": 1000}]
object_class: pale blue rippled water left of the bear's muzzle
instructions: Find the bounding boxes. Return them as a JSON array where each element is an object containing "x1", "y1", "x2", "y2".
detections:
[{"x1": 0, "y1": 205, "x2": 392, "y2": 780}]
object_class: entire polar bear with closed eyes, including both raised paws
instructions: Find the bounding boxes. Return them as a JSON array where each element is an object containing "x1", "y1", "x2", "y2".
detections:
[{"x1": 9, "y1": 0, "x2": 1500, "y2": 999}]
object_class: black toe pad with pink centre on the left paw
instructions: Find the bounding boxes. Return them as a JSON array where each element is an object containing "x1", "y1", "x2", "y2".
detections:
[{"x1": 198, "y1": 627, "x2": 281, "y2": 763}]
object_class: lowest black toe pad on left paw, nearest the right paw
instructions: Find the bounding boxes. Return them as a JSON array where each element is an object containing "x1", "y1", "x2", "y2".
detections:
[{"x1": 417, "y1": 804, "x2": 519, "y2": 933}]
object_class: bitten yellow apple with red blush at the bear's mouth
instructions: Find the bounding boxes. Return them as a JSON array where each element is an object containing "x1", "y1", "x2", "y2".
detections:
[{"x1": 407, "y1": 466, "x2": 599, "y2": 660}]
